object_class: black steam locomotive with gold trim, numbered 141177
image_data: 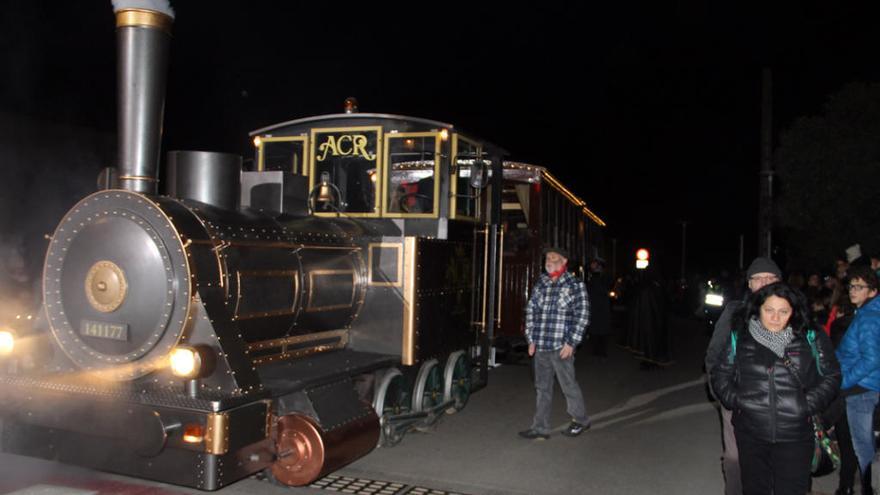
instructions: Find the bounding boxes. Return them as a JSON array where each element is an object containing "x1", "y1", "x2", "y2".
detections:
[{"x1": 0, "y1": 3, "x2": 601, "y2": 490}]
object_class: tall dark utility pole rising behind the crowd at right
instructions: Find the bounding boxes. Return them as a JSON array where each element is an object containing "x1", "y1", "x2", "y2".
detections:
[{"x1": 758, "y1": 67, "x2": 773, "y2": 257}]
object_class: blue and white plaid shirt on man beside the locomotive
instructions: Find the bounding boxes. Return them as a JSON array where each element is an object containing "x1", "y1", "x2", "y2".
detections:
[{"x1": 526, "y1": 272, "x2": 590, "y2": 351}]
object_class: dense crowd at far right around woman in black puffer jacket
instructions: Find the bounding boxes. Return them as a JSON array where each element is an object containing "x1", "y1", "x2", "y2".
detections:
[{"x1": 705, "y1": 250, "x2": 880, "y2": 495}]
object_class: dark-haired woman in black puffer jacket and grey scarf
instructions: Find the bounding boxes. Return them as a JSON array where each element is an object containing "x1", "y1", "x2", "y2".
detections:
[{"x1": 711, "y1": 282, "x2": 840, "y2": 495}]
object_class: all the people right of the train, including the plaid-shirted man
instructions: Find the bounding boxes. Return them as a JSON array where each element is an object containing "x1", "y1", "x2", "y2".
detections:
[{"x1": 519, "y1": 241, "x2": 880, "y2": 495}]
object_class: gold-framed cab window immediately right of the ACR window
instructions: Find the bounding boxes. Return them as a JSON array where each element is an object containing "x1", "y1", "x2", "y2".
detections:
[{"x1": 383, "y1": 132, "x2": 440, "y2": 216}]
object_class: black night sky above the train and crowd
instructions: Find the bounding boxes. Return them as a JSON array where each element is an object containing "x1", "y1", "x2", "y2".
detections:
[{"x1": 0, "y1": 0, "x2": 880, "y2": 280}]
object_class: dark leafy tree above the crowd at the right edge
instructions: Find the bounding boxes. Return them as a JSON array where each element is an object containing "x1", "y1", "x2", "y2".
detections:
[{"x1": 775, "y1": 83, "x2": 880, "y2": 269}]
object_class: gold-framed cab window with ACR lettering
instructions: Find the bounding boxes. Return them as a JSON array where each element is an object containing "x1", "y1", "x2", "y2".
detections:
[{"x1": 309, "y1": 127, "x2": 382, "y2": 216}]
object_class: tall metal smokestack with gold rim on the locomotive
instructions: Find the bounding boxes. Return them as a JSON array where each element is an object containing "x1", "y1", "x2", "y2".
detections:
[{"x1": 113, "y1": 0, "x2": 174, "y2": 194}]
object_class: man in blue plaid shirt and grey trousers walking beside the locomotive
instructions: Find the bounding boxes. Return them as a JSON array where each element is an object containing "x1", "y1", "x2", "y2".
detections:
[{"x1": 519, "y1": 248, "x2": 590, "y2": 439}]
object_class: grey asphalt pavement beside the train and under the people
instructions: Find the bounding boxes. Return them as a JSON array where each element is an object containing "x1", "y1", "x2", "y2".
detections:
[{"x1": 0, "y1": 318, "x2": 837, "y2": 495}]
